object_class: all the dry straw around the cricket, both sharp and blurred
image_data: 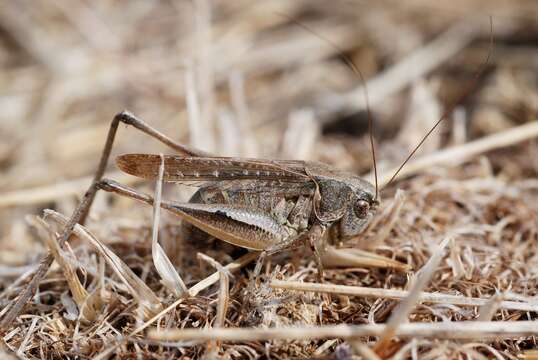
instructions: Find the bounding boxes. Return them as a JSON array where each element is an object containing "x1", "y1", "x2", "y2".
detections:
[{"x1": 0, "y1": 0, "x2": 538, "y2": 360}]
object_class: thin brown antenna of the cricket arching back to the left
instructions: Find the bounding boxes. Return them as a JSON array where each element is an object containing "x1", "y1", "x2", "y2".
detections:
[{"x1": 277, "y1": 12, "x2": 379, "y2": 201}]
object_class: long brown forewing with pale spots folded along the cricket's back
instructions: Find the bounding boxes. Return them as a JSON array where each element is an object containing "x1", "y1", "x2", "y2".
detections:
[{"x1": 116, "y1": 154, "x2": 309, "y2": 182}]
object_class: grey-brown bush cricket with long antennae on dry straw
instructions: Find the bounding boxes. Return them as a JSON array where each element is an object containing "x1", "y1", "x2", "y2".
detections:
[{"x1": 0, "y1": 19, "x2": 493, "y2": 328}]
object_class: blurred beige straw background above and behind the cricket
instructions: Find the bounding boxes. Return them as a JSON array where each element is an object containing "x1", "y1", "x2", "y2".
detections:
[{"x1": 0, "y1": 0, "x2": 538, "y2": 271}]
